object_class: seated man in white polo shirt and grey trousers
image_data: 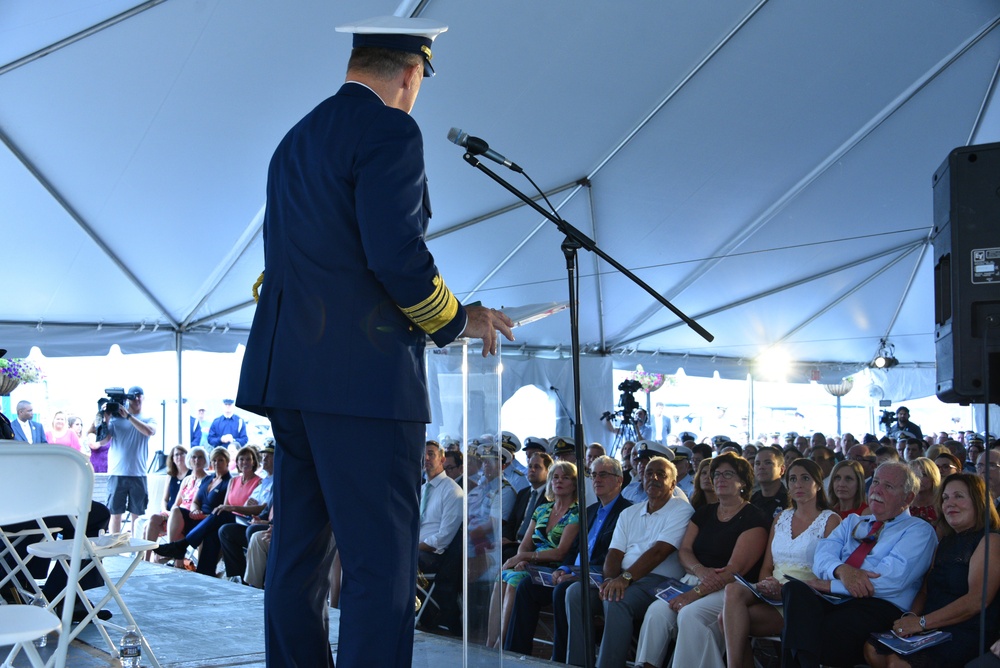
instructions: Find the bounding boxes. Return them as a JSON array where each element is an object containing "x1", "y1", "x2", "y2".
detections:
[{"x1": 566, "y1": 456, "x2": 694, "y2": 668}]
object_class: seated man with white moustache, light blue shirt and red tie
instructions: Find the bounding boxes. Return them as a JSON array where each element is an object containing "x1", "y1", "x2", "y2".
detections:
[{"x1": 781, "y1": 462, "x2": 937, "y2": 668}]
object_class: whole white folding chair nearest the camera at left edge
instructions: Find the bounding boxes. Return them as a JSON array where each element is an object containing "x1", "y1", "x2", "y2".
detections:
[{"x1": 0, "y1": 441, "x2": 94, "y2": 668}]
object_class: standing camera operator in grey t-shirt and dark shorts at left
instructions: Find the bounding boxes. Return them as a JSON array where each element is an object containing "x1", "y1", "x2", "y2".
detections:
[{"x1": 101, "y1": 386, "x2": 156, "y2": 533}]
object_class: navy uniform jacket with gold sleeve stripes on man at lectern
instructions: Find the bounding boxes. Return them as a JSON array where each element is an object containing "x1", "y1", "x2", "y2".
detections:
[{"x1": 236, "y1": 83, "x2": 467, "y2": 422}]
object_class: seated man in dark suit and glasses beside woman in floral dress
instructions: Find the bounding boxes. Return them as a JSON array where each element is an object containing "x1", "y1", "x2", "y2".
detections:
[{"x1": 504, "y1": 457, "x2": 632, "y2": 662}]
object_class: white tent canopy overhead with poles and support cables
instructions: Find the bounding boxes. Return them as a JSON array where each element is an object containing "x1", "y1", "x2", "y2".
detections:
[{"x1": 0, "y1": 0, "x2": 1000, "y2": 382}]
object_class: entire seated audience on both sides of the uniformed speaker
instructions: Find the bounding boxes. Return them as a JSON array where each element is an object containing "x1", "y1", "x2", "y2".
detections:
[{"x1": 7, "y1": 394, "x2": 1000, "y2": 668}]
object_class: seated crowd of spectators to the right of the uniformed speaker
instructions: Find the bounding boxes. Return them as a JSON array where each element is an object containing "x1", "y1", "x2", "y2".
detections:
[{"x1": 412, "y1": 409, "x2": 1000, "y2": 668}]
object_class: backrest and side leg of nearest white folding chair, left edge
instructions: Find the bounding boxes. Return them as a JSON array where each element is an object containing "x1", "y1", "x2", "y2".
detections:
[{"x1": 0, "y1": 441, "x2": 94, "y2": 668}]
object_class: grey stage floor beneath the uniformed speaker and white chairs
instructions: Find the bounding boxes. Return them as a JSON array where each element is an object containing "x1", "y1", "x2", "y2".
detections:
[{"x1": 0, "y1": 557, "x2": 552, "y2": 668}]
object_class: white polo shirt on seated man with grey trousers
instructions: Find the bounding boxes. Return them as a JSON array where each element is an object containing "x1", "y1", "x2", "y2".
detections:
[{"x1": 611, "y1": 496, "x2": 694, "y2": 579}]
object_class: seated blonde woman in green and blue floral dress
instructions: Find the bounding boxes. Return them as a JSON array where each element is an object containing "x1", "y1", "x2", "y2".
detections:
[{"x1": 487, "y1": 462, "x2": 580, "y2": 647}]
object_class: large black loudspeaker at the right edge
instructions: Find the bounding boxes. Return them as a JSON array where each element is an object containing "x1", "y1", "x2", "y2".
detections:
[{"x1": 933, "y1": 143, "x2": 1000, "y2": 404}]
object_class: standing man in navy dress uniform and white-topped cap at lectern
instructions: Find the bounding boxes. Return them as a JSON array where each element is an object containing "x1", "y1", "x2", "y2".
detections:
[{"x1": 236, "y1": 17, "x2": 513, "y2": 668}]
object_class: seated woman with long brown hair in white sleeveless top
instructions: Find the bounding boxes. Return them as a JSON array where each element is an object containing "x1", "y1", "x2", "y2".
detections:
[{"x1": 720, "y1": 459, "x2": 840, "y2": 668}]
